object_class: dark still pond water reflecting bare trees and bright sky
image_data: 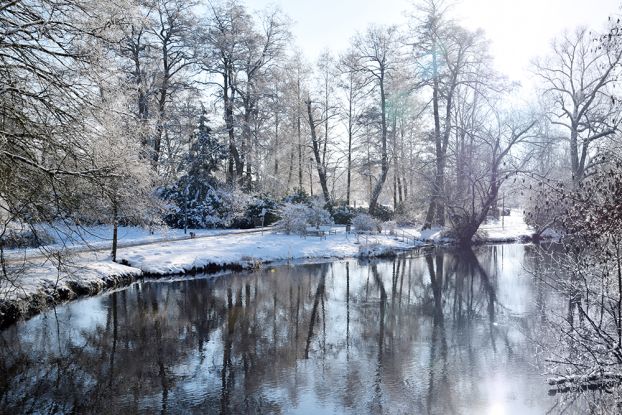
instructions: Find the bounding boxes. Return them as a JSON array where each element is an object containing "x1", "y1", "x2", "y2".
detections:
[{"x1": 0, "y1": 245, "x2": 554, "y2": 414}]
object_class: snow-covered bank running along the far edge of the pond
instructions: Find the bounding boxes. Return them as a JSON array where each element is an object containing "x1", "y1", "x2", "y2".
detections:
[{"x1": 0, "y1": 211, "x2": 532, "y2": 326}]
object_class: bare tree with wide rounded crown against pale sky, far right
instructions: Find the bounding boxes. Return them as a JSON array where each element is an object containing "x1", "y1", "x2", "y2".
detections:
[{"x1": 536, "y1": 28, "x2": 622, "y2": 186}]
